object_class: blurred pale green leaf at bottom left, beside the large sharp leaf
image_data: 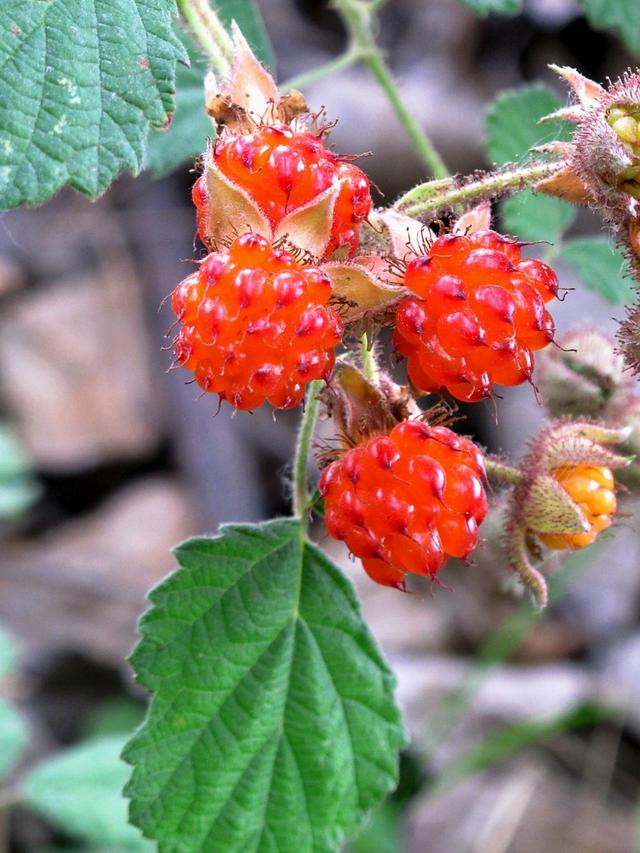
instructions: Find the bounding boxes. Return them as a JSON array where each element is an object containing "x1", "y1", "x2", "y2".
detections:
[{"x1": 23, "y1": 735, "x2": 153, "y2": 851}]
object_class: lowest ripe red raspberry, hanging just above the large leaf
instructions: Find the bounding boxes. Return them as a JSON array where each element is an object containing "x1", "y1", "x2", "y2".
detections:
[{"x1": 320, "y1": 421, "x2": 487, "y2": 588}]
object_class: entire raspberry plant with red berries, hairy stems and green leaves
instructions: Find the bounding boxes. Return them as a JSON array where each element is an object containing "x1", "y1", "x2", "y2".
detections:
[{"x1": 0, "y1": 0, "x2": 640, "y2": 851}]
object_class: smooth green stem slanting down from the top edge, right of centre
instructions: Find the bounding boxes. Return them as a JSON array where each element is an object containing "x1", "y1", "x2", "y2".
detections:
[{"x1": 334, "y1": 0, "x2": 449, "y2": 178}]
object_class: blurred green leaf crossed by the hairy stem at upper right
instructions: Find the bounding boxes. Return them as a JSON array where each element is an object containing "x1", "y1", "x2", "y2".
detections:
[{"x1": 486, "y1": 83, "x2": 575, "y2": 241}]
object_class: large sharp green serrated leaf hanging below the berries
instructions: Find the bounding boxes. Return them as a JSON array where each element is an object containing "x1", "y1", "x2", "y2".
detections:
[{"x1": 124, "y1": 519, "x2": 405, "y2": 853}]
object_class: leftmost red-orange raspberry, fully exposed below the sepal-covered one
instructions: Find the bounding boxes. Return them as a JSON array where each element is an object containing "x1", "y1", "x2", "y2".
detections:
[{"x1": 171, "y1": 234, "x2": 342, "y2": 409}]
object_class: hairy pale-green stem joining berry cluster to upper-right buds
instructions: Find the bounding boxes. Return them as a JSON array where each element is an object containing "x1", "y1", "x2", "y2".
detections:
[{"x1": 395, "y1": 160, "x2": 565, "y2": 216}]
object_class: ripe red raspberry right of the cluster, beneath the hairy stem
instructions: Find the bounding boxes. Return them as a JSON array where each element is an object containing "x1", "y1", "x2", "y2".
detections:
[{"x1": 394, "y1": 231, "x2": 558, "y2": 402}]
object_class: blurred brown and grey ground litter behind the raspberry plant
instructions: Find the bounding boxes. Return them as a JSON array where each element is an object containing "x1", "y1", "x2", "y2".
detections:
[{"x1": 0, "y1": 0, "x2": 640, "y2": 853}]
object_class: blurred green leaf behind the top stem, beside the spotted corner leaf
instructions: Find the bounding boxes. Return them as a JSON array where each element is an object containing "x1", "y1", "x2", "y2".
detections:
[{"x1": 147, "y1": 0, "x2": 274, "y2": 177}]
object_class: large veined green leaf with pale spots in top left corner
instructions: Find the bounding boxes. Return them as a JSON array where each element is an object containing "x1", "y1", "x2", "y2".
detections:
[{"x1": 0, "y1": 0, "x2": 186, "y2": 208}]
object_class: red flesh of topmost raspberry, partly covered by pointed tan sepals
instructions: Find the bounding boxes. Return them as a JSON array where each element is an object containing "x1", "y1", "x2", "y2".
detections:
[{"x1": 193, "y1": 124, "x2": 371, "y2": 257}]
